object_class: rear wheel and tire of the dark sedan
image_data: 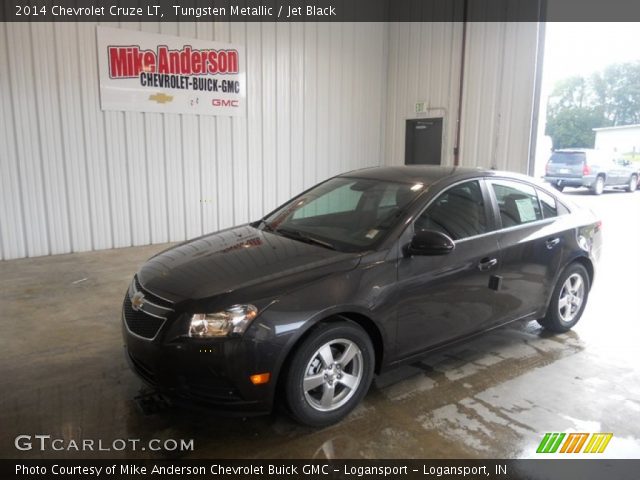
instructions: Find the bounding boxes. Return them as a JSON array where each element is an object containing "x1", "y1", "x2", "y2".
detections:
[{"x1": 538, "y1": 263, "x2": 591, "y2": 333}]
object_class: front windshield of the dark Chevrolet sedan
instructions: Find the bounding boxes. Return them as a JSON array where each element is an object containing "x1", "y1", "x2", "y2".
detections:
[{"x1": 262, "y1": 177, "x2": 424, "y2": 252}]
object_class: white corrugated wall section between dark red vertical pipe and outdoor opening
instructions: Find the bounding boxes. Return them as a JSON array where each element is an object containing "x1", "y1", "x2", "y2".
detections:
[{"x1": 460, "y1": 22, "x2": 538, "y2": 173}]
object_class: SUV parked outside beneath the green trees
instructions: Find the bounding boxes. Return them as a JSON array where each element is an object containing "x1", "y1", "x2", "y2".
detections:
[{"x1": 544, "y1": 149, "x2": 638, "y2": 195}]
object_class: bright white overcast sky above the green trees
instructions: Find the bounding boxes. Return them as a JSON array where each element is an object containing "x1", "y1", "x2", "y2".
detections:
[{"x1": 543, "y1": 22, "x2": 640, "y2": 86}]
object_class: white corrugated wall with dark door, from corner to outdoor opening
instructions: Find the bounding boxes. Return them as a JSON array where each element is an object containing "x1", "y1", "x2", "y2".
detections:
[{"x1": 385, "y1": 22, "x2": 539, "y2": 173}]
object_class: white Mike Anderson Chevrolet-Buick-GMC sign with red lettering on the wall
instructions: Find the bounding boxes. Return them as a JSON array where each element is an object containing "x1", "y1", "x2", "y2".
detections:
[{"x1": 97, "y1": 27, "x2": 246, "y2": 116}]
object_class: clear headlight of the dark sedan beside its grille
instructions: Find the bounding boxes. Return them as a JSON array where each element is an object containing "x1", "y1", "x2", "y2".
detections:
[{"x1": 189, "y1": 305, "x2": 258, "y2": 338}]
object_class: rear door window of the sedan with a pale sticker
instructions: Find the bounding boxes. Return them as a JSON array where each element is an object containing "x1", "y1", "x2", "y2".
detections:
[{"x1": 491, "y1": 181, "x2": 542, "y2": 228}]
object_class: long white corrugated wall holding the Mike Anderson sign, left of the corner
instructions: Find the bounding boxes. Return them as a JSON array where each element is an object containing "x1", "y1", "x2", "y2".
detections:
[{"x1": 0, "y1": 22, "x2": 387, "y2": 259}]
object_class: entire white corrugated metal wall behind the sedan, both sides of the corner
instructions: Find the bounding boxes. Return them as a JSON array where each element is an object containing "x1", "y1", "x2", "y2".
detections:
[{"x1": 0, "y1": 22, "x2": 539, "y2": 259}]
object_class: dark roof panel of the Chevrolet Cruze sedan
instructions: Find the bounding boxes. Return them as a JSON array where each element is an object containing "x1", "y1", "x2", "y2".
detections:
[{"x1": 339, "y1": 165, "x2": 495, "y2": 185}]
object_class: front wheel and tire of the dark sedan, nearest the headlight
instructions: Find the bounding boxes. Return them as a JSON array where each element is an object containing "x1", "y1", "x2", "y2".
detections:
[{"x1": 285, "y1": 321, "x2": 375, "y2": 427}]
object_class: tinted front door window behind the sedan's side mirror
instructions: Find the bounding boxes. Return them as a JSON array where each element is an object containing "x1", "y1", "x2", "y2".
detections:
[{"x1": 414, "y1": 180, "x2": 488, "y2": 240}]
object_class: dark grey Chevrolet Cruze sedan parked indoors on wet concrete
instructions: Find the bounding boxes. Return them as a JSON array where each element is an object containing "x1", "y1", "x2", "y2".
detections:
[{"x1": 122, "y1": 166, "x2": 601, "y2": 426}]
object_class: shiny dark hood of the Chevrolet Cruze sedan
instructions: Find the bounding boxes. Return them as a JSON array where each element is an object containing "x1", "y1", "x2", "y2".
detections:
[{"x1": 138, "y1": 225, "x2": 360, "y2": 302}]
